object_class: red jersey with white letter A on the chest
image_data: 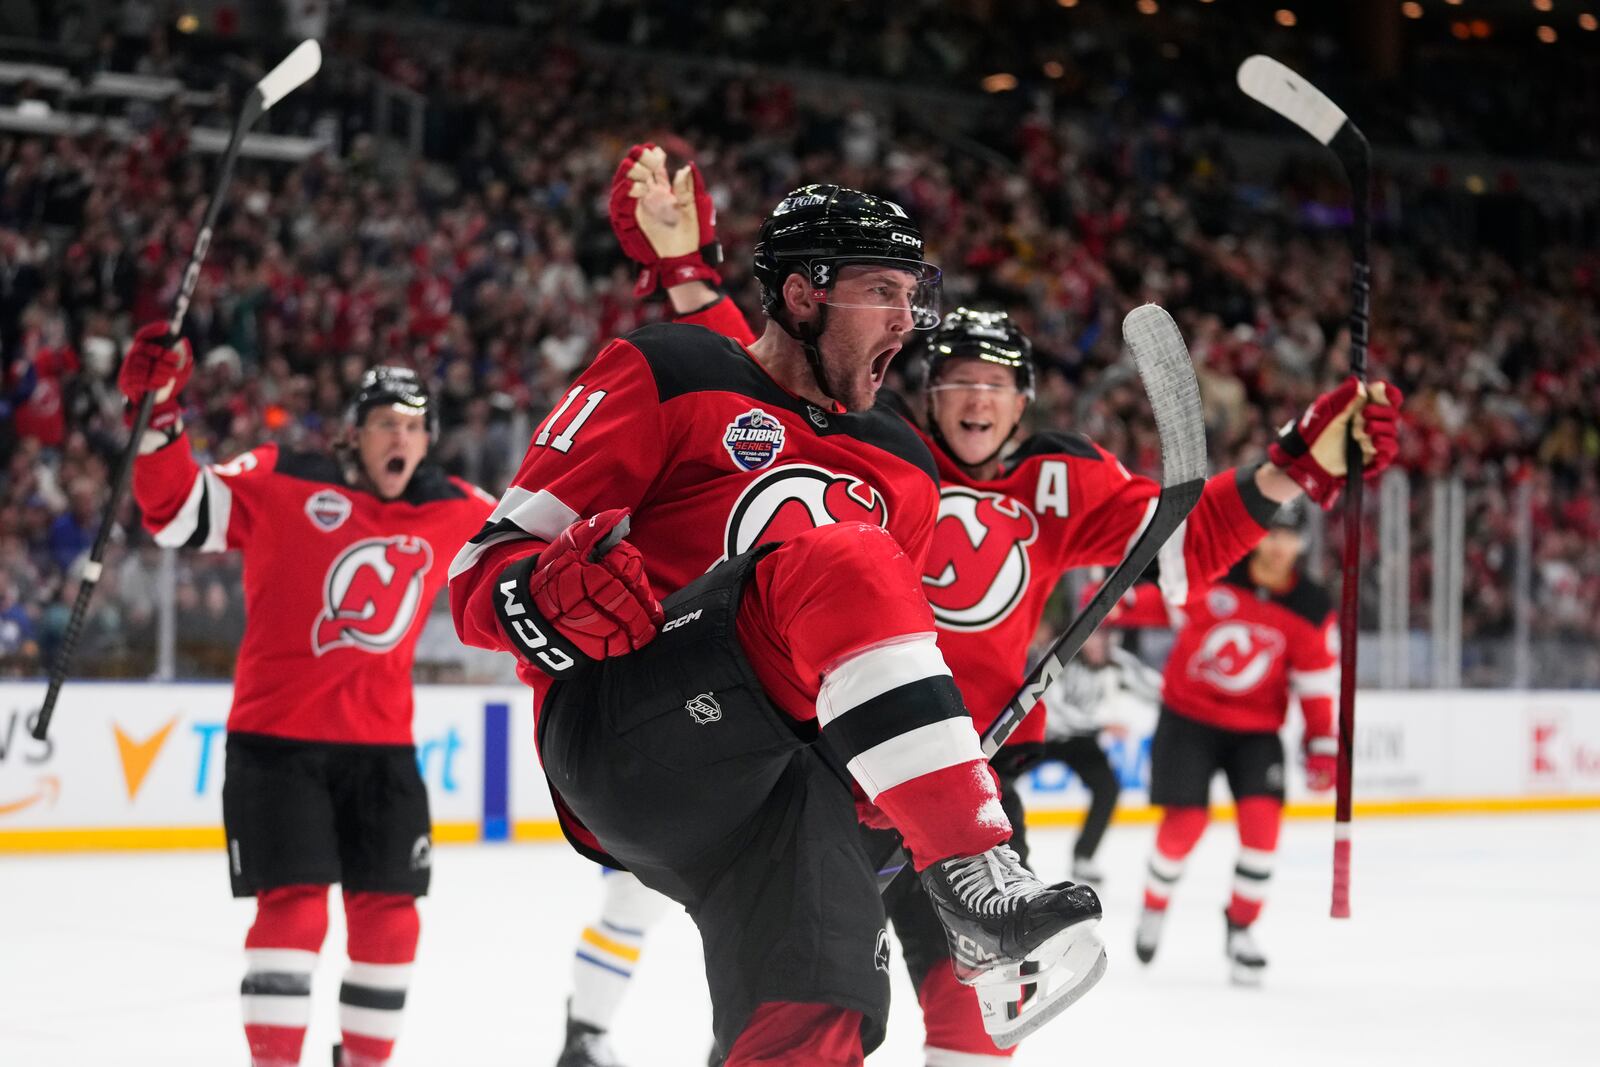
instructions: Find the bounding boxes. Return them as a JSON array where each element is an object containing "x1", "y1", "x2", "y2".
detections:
[{"x1": 922, "y1": 432, "x2": 1277, "y2": 744}]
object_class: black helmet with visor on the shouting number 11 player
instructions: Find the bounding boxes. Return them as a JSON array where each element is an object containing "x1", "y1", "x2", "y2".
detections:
[{"x1": 755, "y1": 186, "x2": 941, "y2": 333}]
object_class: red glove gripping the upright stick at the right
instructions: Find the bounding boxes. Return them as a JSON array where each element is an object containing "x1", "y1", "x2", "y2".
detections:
[{"x1": 1267, "y1": 376, "x2": 1398, "y2": 509}]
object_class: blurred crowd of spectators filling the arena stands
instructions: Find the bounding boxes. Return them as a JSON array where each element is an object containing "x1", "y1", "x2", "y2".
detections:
[{"x1": 0, "y1": 5, "x2": 1600, "y2": 685}]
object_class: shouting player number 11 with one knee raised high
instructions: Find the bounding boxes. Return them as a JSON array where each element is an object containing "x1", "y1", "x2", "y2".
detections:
[{"x1": 451, "y1": 186, "x2": 1104, "y2": 1067}]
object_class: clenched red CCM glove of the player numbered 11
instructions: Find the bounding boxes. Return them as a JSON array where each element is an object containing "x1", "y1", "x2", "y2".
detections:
[{"x1": 528, "y1": 509, "x2": 664, "y2": 659}]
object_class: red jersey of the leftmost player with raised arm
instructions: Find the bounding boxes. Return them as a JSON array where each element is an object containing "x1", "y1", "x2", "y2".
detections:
[{"x1": 133, "y1": 435, "x2": 494, "y2": 744}]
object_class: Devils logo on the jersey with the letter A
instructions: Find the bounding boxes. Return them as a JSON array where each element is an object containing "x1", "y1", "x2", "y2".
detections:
[{"x1": 922, "y1": 486, "x2": 1038, "y2": 630}]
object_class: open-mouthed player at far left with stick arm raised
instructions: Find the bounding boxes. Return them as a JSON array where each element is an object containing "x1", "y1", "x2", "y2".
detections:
[{"x1": 118, "y1": 323, "x2": 493, "y2": 1067}]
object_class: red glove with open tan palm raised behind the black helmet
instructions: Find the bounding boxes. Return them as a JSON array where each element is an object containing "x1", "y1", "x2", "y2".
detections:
[{"x1": 610, "y1": 144, "x2": 722, "y2": 296}]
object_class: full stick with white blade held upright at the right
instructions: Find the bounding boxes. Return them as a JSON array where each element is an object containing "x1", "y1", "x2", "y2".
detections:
[{"x1": 1238, "y1": 56, "x2": 1373, "y2": 918}]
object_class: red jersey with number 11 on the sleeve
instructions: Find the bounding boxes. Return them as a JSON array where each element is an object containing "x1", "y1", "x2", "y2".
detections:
[{"x1": 450, "y1": 323, "x2": 938, "y2": 710}]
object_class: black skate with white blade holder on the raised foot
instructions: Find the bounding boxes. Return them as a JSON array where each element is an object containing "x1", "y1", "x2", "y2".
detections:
[{"x1": 922, "y1": 845, "x2": 1106, "y2": 1048}]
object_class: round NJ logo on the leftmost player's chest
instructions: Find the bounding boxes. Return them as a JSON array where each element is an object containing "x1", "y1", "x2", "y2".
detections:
[{"x1": 310, "y1": 536, "x2": 434, "y2": 656}]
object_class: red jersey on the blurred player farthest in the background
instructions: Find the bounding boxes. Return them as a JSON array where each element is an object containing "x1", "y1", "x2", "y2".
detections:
[{"x1": 1162, "y1": 560, "x2": 1339, "y2": 737}]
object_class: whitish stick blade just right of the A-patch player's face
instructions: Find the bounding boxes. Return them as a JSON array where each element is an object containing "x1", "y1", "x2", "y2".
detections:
[{"x1": 1122, "y1": 304, "x2": 1206, "y2": 486}]
